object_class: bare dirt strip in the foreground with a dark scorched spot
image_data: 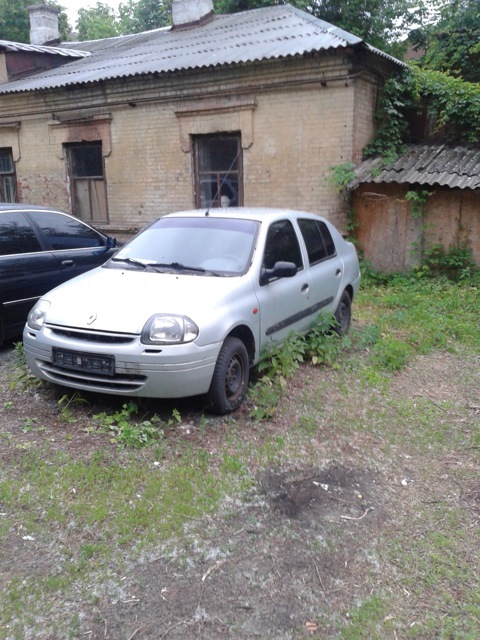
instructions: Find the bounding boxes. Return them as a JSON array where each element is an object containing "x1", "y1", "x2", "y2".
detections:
[{"x1": 83, "y1": 462, "x2": 387, "y2": 640}]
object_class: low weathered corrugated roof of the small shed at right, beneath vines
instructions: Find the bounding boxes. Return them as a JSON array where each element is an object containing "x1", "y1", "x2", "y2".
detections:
[{"x1": 348, "y1": 145, "x2": 480, "y2": 189}]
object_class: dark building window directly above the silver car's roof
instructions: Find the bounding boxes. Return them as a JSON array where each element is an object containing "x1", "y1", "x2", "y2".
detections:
[{"x1": 193, "y1": 134, "x2": 243, "y2": 209}]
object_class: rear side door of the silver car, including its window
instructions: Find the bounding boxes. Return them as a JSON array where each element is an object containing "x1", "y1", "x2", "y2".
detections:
[{"x1": 297, "y1": 218, "x2": 343, "y2": 315}]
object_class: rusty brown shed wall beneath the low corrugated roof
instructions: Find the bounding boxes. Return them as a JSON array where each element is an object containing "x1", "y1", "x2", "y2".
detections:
[{"x1": 353, "y1": 184, "x2": 480, "y2": 272}]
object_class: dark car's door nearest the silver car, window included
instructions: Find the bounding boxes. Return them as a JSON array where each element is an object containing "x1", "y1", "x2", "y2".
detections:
[{"x1": 29, "y1": 211, "x2": 111, "y2": 281}]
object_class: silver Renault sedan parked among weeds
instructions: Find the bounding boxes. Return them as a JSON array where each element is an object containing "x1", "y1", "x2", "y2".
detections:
[{"x1": 23, "y1": 208, "x2": 360, "y2": 414}]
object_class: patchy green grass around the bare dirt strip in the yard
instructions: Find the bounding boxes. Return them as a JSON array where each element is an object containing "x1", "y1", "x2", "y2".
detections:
[{"x1": 0, "y1": 278, "x2": 480, "y2": 640}]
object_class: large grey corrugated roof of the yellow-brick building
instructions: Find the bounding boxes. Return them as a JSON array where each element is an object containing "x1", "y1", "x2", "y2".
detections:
[{"x1": 0, "y1": 5, "x2": 403, "y2": 93}]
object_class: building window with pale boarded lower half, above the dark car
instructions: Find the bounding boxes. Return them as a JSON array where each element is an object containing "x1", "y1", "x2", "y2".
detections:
[{"x1": 67, "y1": 142, "x2": 108, "y2": 222}]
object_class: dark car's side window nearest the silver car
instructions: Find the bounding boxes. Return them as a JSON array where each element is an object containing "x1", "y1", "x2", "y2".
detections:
[{"x1": 31, "y1": 211, "x2": 105, "y2": 250}]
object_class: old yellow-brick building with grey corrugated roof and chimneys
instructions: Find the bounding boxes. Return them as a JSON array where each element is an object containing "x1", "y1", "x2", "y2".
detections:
[{"x1": 0, "y1": 0, "x2": 403, "y2": 237}]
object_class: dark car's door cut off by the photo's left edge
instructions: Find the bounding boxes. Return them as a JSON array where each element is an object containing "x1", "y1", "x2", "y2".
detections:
[{"x1": 0, "y1": 211, "x2": 62, "y2": 341}]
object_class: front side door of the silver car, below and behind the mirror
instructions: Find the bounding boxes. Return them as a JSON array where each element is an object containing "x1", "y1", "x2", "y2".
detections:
[{"x1": 256, "y1": 219, "x2": 311, "y2": 350}]
